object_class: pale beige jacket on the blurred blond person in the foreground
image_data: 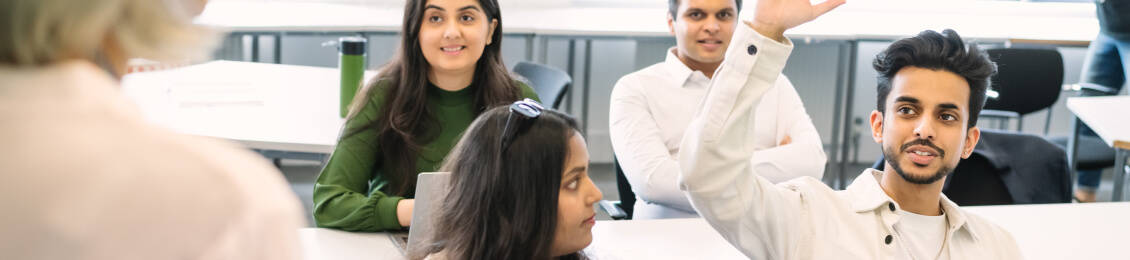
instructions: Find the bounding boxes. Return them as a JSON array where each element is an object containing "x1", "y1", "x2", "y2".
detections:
[{"x1": 0, "y1": 61, "x2": 303, "y2": 259}]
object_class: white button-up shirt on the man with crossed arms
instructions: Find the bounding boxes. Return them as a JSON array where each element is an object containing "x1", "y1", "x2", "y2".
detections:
[{"x1": 608, "y1": 25, "x2": 827, "y2": 219}]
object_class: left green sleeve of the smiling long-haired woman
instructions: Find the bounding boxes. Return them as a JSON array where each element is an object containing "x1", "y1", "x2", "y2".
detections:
[{"x1": 313, "y1": 81, "x2": 403, "y2": 232}]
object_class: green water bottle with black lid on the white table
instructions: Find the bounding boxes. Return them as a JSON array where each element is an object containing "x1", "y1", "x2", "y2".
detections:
[{"x1": 338, "y1": 36, "x2": 367, "y2": 118}]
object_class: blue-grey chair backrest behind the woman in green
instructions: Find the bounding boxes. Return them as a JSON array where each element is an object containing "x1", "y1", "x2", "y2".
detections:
[{"x1": 514, "y1": 61, "x2": 573, "y2": 110}]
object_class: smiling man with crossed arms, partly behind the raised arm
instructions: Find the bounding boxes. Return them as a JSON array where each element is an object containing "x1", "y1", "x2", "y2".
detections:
[{"x1": 609, "y1": 0, "x2": 827, "y2": 219}]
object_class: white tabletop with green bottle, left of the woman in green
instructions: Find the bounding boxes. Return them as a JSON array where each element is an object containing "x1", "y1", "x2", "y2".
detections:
[{"x1": 122, "y1": 61, "x2": 372, "y2": 154}]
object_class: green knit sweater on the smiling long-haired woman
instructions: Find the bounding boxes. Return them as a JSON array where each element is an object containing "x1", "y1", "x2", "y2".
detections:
[{"x1": 314, "y1": 79, "x2": 538, "y2": 232}]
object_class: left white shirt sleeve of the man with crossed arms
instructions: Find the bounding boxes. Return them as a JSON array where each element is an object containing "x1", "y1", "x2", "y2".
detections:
[{"x1": 608, "y1": 75, "x2": 694, "y2": 211}]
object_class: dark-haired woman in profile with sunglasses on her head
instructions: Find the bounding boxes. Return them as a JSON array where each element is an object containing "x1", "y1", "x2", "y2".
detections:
[{"x1": 410, "y1": 99, "x2": 602, "y2": 260}]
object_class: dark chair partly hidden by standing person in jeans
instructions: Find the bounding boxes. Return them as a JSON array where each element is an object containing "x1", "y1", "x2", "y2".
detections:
[{"x1": 1048, "y1": 84, "x2": 1119, "y2": 182}]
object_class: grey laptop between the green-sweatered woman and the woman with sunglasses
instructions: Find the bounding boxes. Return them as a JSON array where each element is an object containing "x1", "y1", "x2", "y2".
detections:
[{"x1": 391, "y1": 172, "x2": 451, "y2": 254}]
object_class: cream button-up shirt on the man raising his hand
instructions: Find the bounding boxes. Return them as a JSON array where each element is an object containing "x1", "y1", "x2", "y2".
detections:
[{"x1": 679, "y1": 25, "x2": 1022, "y2": 259}]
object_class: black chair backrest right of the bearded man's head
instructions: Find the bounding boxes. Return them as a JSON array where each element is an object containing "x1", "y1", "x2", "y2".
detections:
[{"x1": 984, "y1": 47, "x2": 1063, "y2": 116}]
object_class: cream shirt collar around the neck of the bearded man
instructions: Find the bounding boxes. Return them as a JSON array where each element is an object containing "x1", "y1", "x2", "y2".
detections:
[{"x1": 845, "y1": 168, "x2": 979, "y2": 242}]
